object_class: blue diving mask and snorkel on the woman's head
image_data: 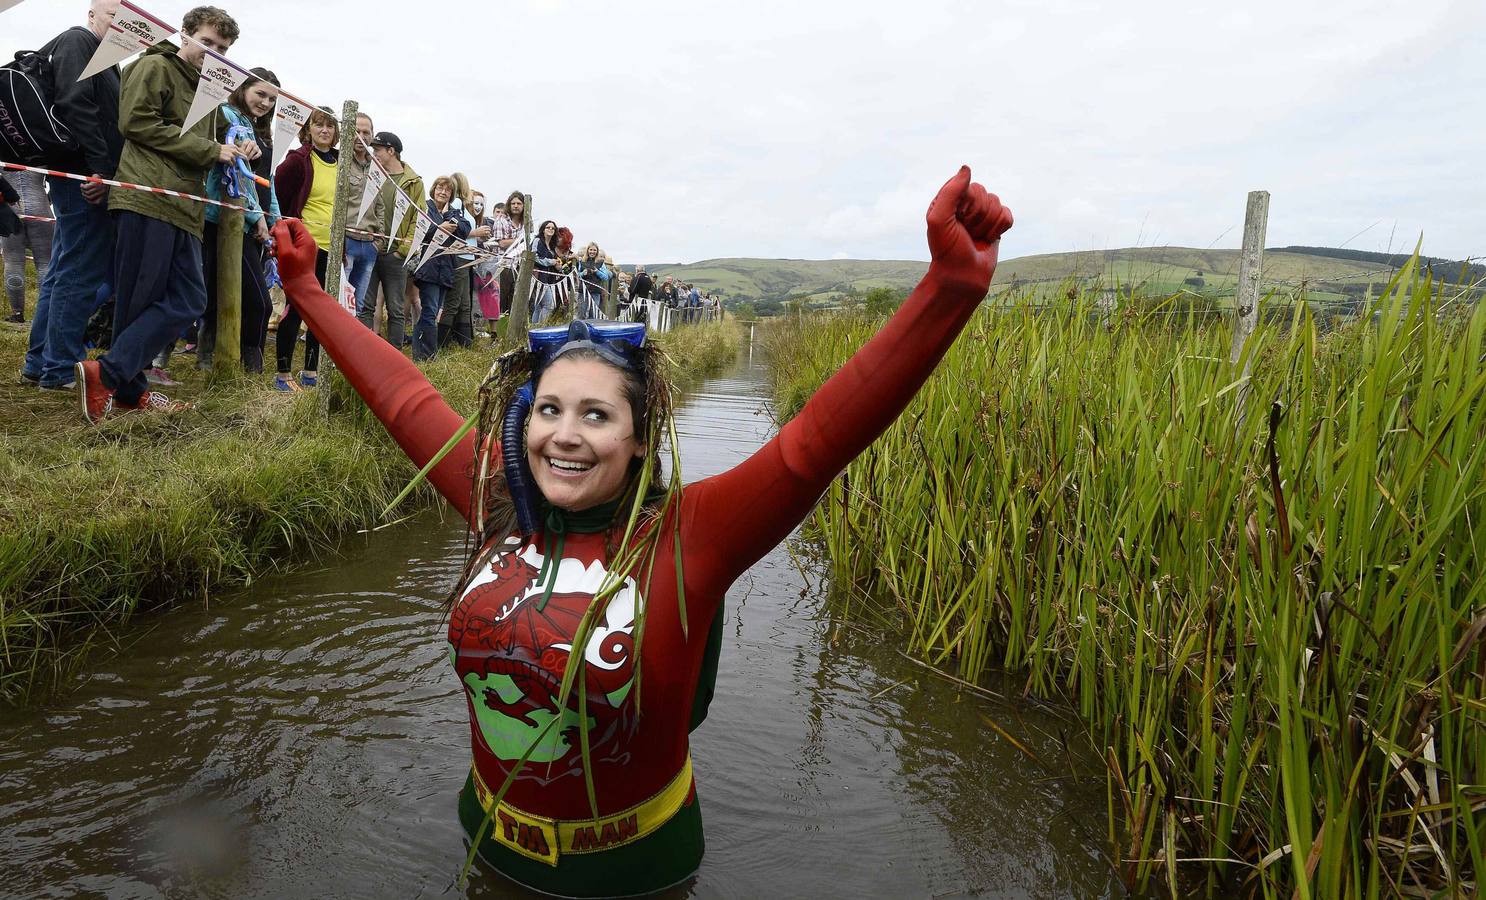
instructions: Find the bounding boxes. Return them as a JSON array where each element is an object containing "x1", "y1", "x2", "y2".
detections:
[{"x1": 501, "y1": 319, "x2": 645, "y2": 535}]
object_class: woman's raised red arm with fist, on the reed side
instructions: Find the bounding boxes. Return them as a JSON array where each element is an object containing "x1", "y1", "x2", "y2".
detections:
[{"x1": 682, "y1": 166, "x2": 1012, "y2": 594}]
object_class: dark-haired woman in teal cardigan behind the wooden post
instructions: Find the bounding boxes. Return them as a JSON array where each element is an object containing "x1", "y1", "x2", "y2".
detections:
[{"x1": 196, "y1": 68, "x2": 281, "y2": 373}]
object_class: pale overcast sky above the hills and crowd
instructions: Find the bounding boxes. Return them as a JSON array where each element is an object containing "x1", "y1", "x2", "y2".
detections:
[{"x1": 0, "y1": 0, "x2": 1486, "y2": 263}]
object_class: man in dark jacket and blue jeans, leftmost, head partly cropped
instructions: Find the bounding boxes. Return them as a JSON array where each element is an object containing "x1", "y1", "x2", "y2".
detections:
[{"x1": 21, "y1": 0, "x2": 123, "y2": 391}]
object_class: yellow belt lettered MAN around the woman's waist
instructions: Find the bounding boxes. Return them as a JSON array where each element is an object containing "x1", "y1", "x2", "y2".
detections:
[{"x1": 470, "y1": 753, "x2": 691, "y2": 866}]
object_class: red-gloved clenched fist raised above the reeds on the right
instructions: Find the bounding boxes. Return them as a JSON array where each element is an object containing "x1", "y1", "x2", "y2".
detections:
[{"x1": 927, "y1": 166, "x2": 1012, "y2": 301}]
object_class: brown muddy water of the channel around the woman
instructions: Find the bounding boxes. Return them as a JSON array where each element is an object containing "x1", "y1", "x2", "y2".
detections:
[{"x1": 0, "y1": 347, "x2": 1120, "y2": 897}]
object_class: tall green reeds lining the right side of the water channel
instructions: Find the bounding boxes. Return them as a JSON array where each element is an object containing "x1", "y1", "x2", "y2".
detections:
[{"x1": 773, "y1": 269, "x2": 1486, "y2": 897}]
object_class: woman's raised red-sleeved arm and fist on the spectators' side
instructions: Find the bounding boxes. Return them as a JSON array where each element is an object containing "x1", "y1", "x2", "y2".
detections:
[{"x1": 273, "y1": 218, "x2": 474, "y2": 521}]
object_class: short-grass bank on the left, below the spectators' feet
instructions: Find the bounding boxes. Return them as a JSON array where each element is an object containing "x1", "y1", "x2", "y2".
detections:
[{"x1": 0, "y1": 313, "x2": 739, "y2": 702}]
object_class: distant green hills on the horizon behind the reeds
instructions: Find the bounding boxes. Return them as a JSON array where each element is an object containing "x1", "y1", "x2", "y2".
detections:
[{"x1": 648, "y1": 247, "x2": 1459, "y2": 313}]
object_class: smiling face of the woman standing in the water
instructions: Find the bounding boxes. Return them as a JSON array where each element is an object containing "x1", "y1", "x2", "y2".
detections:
[{"x1": 526, "y1": 358, "x2": 645, "y2": 511}]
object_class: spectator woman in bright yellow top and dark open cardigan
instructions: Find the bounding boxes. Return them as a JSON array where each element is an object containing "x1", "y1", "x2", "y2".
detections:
[{"x1": 273, "y1": 107, "x2": 340, "y2": 391}]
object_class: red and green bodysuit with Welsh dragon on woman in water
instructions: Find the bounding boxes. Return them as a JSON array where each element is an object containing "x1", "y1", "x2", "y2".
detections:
[{"x1": 285, "y1": 191, "x2": 1009, "y2": 896}]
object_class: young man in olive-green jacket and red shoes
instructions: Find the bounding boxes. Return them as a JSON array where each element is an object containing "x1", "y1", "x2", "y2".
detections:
[{"x1": 77, "y1": 6, "x2": 248, "y2": 422}]
